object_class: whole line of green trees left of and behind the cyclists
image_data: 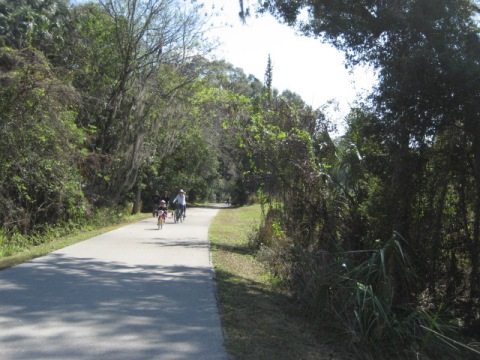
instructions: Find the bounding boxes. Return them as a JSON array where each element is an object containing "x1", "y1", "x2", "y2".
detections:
[{"x1": 0, "y1": 0, "x2": 278, "y2": 245}]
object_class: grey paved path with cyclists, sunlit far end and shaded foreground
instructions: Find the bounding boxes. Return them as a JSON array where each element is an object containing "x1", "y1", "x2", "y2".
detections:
[{"x1": 0, "y1": 208, "x2": 228, "y2": 360}]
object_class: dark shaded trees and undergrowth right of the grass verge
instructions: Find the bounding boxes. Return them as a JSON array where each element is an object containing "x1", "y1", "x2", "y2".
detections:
[{"x1": 234, "y1": 0, "x2": 480, "y2": 358}]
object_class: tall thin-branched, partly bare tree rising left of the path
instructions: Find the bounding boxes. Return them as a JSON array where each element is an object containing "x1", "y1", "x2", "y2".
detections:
[{"x1": 67, "y1": 0, "x2": 212, "y2": 205}]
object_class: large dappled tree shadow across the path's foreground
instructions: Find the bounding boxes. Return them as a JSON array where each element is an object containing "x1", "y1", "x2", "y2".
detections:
[{"x1": 0, "y1": 254, "x2": 225, "y2": 359}]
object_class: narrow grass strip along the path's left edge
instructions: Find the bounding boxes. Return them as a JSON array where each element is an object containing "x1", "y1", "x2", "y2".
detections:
[{"x1": 0, "y1": 213, "x2": 152, "y2": 270}]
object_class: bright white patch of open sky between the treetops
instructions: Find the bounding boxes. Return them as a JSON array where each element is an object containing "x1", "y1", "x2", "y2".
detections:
[{"x1": 204, "y1": 0, "x2": 375, "y2": 132}]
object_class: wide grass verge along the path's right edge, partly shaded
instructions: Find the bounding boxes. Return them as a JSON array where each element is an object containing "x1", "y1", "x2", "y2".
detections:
[{"x1": 209, "y1": 205, "x2": 340, "y2": 360}]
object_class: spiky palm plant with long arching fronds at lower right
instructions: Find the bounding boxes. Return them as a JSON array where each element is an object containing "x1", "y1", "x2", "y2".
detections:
[{"x1": 329, "y1": 234, "x2": 460, "y2": 359}]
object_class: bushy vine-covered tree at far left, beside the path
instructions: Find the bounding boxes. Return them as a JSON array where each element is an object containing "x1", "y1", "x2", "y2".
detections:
[{"x1": 0, "y1": 48, "x2": 86, "y2": 234}]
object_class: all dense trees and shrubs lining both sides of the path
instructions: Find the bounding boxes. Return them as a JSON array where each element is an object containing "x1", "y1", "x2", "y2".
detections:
[{"x1": 0, "y1": 0, "x2": 480, "y2": 358}]
